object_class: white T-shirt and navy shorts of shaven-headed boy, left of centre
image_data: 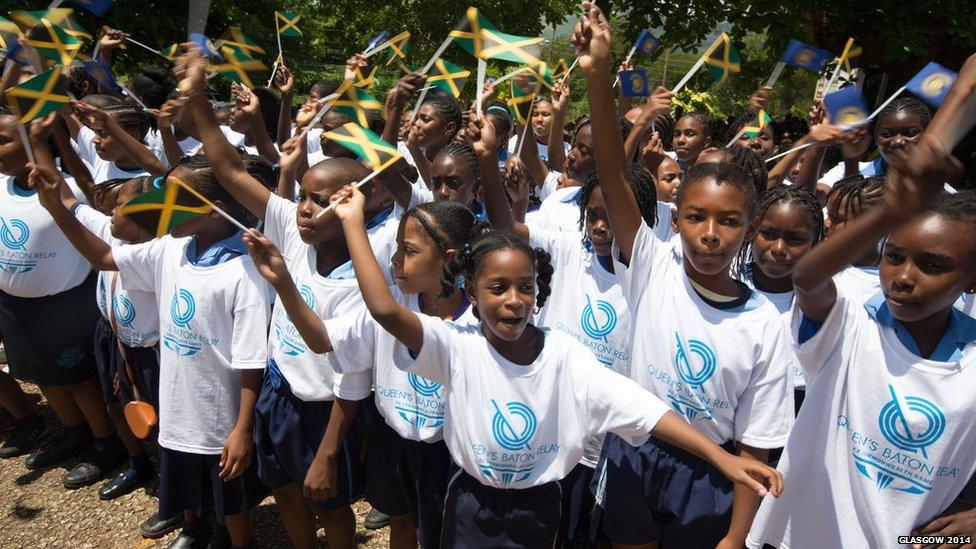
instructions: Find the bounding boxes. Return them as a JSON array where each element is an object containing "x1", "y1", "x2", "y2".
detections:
[{"x1": 255, "y1": 195, "x2": 371, "y2": 510}]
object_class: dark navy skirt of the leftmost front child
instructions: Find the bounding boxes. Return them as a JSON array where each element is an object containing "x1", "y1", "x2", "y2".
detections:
[{"x1": 0, "y1": 271, "x2": 101, "y2": 385}]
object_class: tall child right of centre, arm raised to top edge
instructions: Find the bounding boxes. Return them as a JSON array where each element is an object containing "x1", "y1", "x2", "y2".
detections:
[{"x1": 573, "y1": 2, "x2": 793, "y2": 547}]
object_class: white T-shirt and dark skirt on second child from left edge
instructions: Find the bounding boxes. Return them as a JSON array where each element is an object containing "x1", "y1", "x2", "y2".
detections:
[{"x1": 74, "y1": 204, "x2": 159, "y2": 407}]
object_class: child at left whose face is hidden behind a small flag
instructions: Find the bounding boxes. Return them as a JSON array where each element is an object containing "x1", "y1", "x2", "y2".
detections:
[{"x1": 32, "y1": 155, "x2": 268, "y2": 547}]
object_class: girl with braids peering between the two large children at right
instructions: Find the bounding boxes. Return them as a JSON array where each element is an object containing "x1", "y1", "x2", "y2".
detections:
[{"x1": 738, "y1": 185, "x2": 824, "y2": 410}]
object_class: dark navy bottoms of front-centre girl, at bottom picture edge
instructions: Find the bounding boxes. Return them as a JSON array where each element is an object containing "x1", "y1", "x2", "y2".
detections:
[{"x1": 441, "y1": 463, "x2": 562, "y2": 549}]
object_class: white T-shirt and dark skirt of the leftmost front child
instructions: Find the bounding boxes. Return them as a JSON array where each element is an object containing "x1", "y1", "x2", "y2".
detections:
[{"x1": 0, "y1": 176, "x2": 98, "y2": 385}]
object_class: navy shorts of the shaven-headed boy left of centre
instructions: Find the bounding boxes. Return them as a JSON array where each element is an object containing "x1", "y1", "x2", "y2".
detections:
[{"x1": 254, "y1": 360, "x2": 365, "y2": 510}]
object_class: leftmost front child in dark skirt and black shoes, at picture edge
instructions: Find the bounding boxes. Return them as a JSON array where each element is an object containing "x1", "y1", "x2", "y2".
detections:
[{"x1": 0, "y1": 110, "x2": 125, "y2": 485}]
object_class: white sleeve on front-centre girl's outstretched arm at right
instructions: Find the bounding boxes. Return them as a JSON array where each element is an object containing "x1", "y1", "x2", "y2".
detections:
[{"x1": 569, "y1": 360, "x2": 668, "y2": 439}]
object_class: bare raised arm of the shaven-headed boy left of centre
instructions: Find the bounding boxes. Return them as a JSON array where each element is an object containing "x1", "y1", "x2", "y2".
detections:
[{"x1": 179, "y1": 43, "x2": 271, "y2": 219}]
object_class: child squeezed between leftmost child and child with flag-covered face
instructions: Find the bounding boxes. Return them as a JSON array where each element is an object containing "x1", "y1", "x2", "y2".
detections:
[{"x1": 38, "y1": 173, "x2": 159, "y2": 494}]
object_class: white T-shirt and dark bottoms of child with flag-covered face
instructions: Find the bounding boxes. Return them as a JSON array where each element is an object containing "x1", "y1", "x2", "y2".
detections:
[{"x1": 112, "y1": 232, "x2": 268, "y2": 522}]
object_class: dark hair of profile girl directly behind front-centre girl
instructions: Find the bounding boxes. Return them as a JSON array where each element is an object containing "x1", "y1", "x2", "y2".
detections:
[{"x1": 403, "y1": 200, "x2": 490, "y2": 298}]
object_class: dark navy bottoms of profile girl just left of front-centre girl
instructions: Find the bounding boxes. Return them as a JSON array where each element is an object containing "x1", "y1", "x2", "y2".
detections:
[{"x1": 366, "y1": 400, "x2": 451, "y2": 547}]
